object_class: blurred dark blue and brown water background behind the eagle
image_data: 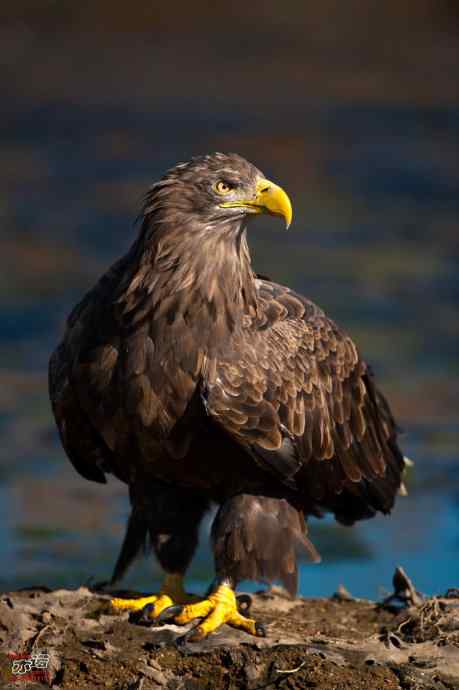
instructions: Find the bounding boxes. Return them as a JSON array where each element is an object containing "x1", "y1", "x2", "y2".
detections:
[{"x1": 0, "y1": 0, "x2": 459, "y2": 597}]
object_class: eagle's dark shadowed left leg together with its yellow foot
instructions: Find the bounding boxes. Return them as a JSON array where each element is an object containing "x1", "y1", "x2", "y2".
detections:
[{"x1": 112, "y1": 482, "x2": 209, "y2": 620}]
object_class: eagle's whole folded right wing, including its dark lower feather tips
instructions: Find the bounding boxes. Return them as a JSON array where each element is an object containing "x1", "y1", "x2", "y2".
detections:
[{"x1": 206, "y1": 281, "x2": 403, "y2": 521}]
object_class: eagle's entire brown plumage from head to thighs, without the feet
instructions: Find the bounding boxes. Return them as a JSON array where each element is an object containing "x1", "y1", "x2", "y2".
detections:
[{"x1": 50, "y1": 154, "x2": 404, "y2": 593}]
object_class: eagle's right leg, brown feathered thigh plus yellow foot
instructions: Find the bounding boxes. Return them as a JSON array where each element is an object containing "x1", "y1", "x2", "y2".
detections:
[{"x1": 164, "y1": 494, "x2": 319, "y2": 642}]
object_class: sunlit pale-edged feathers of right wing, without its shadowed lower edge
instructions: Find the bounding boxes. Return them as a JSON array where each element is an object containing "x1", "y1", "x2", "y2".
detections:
[{"x1": 210, "y1": 281, "x2": 399, "y2": 500}]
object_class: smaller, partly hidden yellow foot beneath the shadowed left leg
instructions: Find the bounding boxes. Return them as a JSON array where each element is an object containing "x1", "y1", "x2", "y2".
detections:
[{"x1": 111, "y1": 575, "x2": 199, "y2": 621}]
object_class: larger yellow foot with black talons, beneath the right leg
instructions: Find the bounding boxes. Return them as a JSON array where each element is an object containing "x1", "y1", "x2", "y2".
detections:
[{"x1": 164, "y1": 584, "x2": 266, "y2": 642}]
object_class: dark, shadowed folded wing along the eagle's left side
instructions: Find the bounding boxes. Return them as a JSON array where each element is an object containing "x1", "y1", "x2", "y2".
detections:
[{"x1": 48, "y1": 255, "x2": 127, "y2": 482}]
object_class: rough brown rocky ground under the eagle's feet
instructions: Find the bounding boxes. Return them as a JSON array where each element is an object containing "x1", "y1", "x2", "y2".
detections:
[{"x1": 0, "y1": 571, "x2": 459, "y2": 690}]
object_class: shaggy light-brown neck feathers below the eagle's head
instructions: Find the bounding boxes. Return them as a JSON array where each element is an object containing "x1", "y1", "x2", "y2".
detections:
[{"x1": 120, "y1": 199, "x2": 258, "y2": 354}]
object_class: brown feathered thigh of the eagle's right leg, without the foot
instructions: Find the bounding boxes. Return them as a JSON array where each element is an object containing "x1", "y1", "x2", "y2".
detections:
[{"x1": 212, "y1": 494, "x2": 320, "y2": 596}]
